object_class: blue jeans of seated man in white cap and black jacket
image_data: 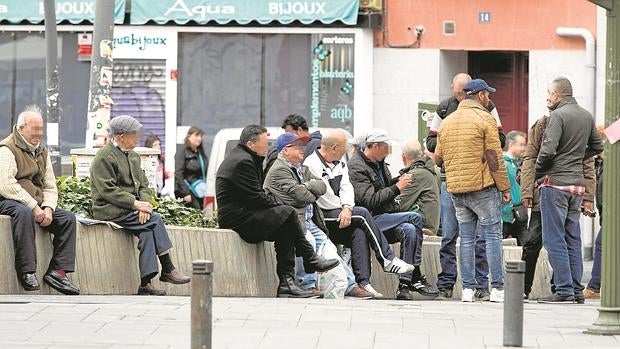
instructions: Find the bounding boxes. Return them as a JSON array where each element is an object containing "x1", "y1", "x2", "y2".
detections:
[{"x1": 374, "y1": 212, "x2": 424, "y2": 283}]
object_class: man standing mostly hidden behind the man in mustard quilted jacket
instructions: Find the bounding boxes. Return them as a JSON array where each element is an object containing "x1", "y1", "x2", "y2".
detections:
[{"x1": 426, "y1": 73, "x2": 506, "y2": 300}]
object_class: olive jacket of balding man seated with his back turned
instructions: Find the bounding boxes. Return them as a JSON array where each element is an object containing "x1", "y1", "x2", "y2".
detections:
[{"x1": 400, "y1": 156, "x2": 440, "y2": 234}]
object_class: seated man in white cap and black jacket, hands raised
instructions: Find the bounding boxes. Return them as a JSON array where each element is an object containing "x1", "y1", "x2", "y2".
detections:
[{"x1": 349, "y1": 129, "x2": 439, "y2": 300}]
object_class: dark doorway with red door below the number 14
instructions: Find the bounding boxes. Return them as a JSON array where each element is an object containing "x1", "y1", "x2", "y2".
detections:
[{"x1": 468, "y1": 51, "x2": 529, "y2": 133}]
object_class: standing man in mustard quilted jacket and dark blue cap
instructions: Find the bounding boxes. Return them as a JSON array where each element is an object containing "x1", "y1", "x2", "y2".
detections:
[{"x1": 435, "y1": 79, "x2": 510, "y2": 302}]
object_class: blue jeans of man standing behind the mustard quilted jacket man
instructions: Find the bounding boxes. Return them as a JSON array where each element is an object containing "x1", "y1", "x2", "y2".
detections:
[{"x1": 437, "y1": 181, "x2": 489, "y2": 289}]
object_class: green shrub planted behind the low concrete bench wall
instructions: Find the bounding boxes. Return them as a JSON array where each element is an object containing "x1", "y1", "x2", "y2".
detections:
[{"x1": 56, "y1": 176, "x2": 217, "y2": 228}]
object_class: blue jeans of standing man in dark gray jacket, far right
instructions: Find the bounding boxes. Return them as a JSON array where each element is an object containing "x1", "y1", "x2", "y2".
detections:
[{"x1": 540, "y1": 187, "x2": 583, "y2": 296}]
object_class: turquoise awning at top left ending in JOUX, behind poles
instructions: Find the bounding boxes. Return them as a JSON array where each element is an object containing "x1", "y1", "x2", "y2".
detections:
[{"x1": 0, "y1": 0, "x2": 125, "y2": 24}]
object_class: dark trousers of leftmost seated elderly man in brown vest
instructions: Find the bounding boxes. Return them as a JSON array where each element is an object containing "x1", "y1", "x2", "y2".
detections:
[{"x1": 0, "y1": 200, "x2": 76, "y2": 274}]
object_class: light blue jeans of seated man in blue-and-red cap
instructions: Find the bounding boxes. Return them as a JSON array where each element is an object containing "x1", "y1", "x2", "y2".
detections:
[{"x1": 295, "y1": 221, "x2": 356, "y2": 294}]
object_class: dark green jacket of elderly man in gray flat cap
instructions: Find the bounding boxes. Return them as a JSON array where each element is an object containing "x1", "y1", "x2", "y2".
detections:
[{"x1": 90, "y1": 143, "x2": 155, "y2": 221}]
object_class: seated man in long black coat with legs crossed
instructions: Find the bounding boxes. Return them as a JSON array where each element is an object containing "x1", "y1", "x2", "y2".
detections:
[{"x1": 215, "y1": 125, "x2": 339, "y2": 297}]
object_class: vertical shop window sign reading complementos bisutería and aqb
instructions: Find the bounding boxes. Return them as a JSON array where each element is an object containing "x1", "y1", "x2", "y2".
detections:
[{"x1": 310, "y1": 34, "x2": 355, "y2": 132}]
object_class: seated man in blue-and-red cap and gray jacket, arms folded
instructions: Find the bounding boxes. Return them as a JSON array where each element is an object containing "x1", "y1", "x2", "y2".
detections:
[{"x1": 264, "y1": 133, "x2": 373, "y2": 298}]
